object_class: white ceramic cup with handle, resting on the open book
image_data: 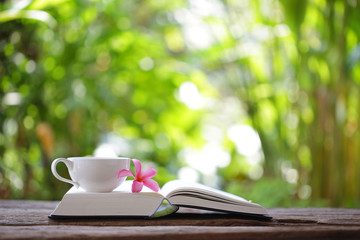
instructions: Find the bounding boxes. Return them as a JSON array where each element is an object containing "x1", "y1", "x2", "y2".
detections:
[{"x1": 51, "y1": 157, "x2": 130, "y2": 192}]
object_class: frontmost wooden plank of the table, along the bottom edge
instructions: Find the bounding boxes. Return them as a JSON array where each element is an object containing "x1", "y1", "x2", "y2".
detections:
[{"x1": 0, "y1": 226, "x2": 360, "y2": 240}]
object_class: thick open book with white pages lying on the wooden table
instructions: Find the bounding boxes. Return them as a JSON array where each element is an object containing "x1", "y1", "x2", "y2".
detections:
[{"x1": 49, "y1": 180, "x2": 271, "y2": 219}]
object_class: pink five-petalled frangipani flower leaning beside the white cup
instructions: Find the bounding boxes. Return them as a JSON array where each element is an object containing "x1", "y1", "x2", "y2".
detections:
[{"x1": 118, "y1": 159, "x2": 159, "y2": 193}]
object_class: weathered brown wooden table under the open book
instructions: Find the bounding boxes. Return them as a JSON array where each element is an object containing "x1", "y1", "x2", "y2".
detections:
[{"x1": 0, "y1": 200, "x2": 360, "y2": 240}]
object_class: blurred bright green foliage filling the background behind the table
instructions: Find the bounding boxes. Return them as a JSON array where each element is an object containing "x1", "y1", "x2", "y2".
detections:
[{"x1": 0, "y1": 0, "x2": 360, "y2": 207}]
